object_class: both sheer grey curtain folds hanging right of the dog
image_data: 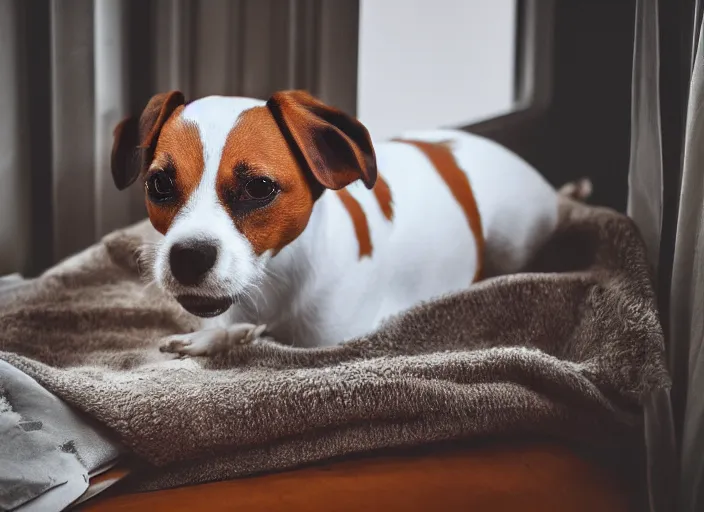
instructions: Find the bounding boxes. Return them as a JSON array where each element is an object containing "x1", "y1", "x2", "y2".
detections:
[{"x1": 629, "y1": 0, "x2": 704, "y2": 512}]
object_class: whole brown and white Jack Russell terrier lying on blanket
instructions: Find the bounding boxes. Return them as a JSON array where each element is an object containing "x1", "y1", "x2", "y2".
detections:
[{"x1": 111, "y1": 91, "x2": 572, "y2": 356}]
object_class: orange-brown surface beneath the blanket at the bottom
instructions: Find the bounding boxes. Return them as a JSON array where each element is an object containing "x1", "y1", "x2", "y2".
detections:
[{"x1": 84, "y1": 442, "x2": 632, "y2": 512}]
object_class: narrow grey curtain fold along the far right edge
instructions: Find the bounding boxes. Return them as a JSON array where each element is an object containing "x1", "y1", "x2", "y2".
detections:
[{"x1": 670, "y1": 10, "x2": 704, "y2": 511}]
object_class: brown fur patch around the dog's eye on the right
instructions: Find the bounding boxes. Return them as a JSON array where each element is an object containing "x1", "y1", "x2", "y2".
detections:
[{"x1": 216, "y1": 107, "x2": 314, "y2": 255}]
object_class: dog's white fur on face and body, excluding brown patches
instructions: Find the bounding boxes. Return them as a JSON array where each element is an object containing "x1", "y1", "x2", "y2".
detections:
[{"x1": 155, "y1": 97, "x2": 557, "y2": 355}]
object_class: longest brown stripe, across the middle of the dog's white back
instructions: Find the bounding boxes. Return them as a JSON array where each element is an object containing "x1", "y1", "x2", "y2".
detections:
[{"x1": 395, "y1": 139, "x2": 485, "y2": 282}]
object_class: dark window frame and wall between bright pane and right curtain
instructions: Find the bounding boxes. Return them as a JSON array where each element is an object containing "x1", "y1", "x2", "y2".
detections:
[{"x1": 459, "y1": 0, "x2": 636, "y2": 212}]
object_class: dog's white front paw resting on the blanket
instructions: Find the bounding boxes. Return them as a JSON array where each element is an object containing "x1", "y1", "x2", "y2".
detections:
[{"x1": 159, "y1": 323, "x2": 266, "y2": 357}]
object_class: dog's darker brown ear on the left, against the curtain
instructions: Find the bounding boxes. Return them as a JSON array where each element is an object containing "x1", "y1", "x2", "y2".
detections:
[{"x1": 110, "y1": 91, "x2": 186, "y2": 190}]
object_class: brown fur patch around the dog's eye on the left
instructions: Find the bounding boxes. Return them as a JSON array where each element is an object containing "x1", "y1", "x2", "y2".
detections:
[{"x1": 146, "y1": 106, "x2": 205, "y2": 234}]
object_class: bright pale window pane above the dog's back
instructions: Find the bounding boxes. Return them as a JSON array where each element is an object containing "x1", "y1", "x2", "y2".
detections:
[{"x1": 357, "y1": 0, "x2": 516, "y2": 138}]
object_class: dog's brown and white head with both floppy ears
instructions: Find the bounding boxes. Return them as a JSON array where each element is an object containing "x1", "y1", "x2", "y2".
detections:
[{"x1": 111, "y1": 91, "x2": 377, "y2": 317}]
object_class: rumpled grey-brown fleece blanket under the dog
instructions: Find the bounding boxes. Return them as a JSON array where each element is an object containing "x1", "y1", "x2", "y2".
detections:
[{"x1": 0, "y1": 194, "x2": 669, "y2": 490}]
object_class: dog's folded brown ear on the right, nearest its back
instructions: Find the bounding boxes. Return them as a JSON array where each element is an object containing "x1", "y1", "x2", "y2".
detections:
[{"x1": 267, "y1": 91, "x2": 377, "y2": 190}]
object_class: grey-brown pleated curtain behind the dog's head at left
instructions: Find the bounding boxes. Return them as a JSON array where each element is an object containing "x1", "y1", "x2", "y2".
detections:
[{"x1": 0, "y1": 0, "x2": 359, "y2": 275}]
